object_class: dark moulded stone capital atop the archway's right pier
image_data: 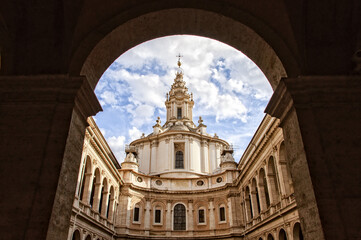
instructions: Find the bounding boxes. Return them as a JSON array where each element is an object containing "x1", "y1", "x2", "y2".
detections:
[{"x1": 265, "y1": 75, "x2": 361, "y2": 122}]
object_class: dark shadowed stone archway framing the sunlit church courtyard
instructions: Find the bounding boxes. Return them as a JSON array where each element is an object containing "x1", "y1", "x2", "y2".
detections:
[{"x1": 0, "y1": 0, "x2": 361, "y2": 239}]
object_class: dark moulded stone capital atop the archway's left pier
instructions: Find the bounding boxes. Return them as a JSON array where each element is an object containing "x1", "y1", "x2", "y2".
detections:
[{"x1": 0, "y1": 75, "x2": 102, "y2": 121}]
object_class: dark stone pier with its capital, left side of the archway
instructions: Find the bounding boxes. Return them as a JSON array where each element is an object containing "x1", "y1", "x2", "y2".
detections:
[{"x1": 0, "y1": 75, "x2": 101, "y2": 239}]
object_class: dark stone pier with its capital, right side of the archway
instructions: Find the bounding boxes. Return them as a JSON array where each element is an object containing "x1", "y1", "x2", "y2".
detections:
[{"x1": 266, "y1": 76, "x2": 361, "y2": 240}]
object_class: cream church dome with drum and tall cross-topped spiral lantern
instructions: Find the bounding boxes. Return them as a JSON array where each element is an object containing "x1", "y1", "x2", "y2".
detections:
[{"x1": 126, "y1": 55, "x2": 229, "y2": 178}]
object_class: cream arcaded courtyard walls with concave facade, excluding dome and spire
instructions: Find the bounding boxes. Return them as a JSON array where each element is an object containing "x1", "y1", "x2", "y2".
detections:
[{"x1": 68, "y1": 116, "x2": 303, "y2": 240}]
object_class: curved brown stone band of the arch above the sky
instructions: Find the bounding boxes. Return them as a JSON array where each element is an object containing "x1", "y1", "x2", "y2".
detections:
[{"x1": 74, "y1": 8, "x2": 298, "y2": 89}]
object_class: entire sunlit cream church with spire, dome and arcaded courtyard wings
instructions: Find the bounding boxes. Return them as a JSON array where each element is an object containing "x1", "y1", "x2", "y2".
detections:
[{"x1": 68, "y1": 61, "x2": 303, "y2": 240}]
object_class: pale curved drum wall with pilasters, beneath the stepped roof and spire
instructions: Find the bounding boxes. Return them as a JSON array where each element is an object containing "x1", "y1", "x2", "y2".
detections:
[{"x1": 131, "y1": 132, "x2": 229, "y2": 177}]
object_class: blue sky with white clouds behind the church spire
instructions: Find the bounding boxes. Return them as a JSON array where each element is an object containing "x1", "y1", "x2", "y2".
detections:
[{"x1": 94, "y1": 35, "x2": 272, "y2": 163}]
